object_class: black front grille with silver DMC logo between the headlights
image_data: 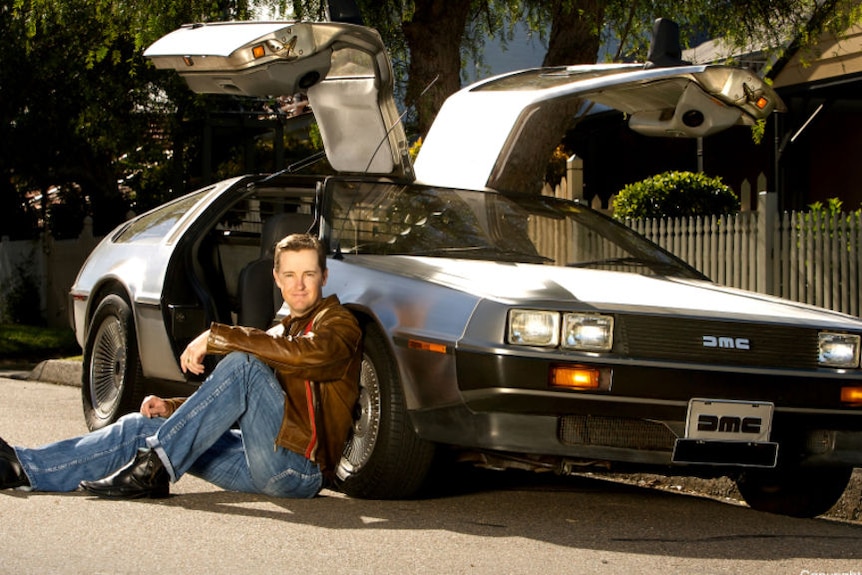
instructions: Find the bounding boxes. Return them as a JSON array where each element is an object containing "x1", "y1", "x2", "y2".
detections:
[{"x1": 615, "y1": 315, "x2": 818, "y2": 369}]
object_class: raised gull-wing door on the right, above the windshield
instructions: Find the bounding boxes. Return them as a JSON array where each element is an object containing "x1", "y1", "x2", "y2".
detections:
[{"x1": 415, "y1": 64, "x2": 784, "y2": 193}]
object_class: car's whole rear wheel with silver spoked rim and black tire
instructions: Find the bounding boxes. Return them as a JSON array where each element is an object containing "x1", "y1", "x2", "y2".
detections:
[{"x1": 81, "y1": 294, "x2": 144, "y2": 430}]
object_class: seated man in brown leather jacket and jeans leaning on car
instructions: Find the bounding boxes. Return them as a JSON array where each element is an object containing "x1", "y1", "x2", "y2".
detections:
[{"x1": 0, "y1": 234, "x2": 362, "y2": 499}]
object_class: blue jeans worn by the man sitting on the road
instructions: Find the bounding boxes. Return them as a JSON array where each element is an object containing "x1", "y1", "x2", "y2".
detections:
[{"x1": 15, "y1": 352, "x2": 323, "y2": 497}]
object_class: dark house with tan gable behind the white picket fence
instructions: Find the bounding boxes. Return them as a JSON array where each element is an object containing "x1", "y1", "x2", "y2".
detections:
[{"x1": 565, "y1": 25, "x2": 862, "y2": 214}]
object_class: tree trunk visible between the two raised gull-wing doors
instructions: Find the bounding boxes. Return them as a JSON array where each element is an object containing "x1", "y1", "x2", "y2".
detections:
[{"x1": 402, "y1": 0, "x2": 470, "y2": 136}]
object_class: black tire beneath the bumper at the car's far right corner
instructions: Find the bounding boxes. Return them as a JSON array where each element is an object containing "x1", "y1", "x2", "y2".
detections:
[{"x1": 736, "y1": 467, "x2": 853, "y2": 517}]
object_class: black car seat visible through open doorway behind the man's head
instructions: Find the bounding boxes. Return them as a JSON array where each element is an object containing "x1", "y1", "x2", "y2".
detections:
[{"x1": 237, "y1": 213, "x2": 314, "y2": 329}]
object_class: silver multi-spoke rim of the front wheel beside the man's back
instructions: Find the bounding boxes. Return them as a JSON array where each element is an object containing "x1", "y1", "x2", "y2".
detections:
[{"x1": 338, "y1": 355, "x2": 381, "y2": 479}]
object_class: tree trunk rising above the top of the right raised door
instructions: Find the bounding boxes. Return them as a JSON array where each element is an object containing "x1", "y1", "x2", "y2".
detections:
[{"x1": 542, "y1": 0, "x2": 606, "y2": 66}]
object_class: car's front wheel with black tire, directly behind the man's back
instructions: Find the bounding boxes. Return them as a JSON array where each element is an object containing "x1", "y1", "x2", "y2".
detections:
[{"x1": 336, "y1": 325, "x2": 435, "y2": 499}]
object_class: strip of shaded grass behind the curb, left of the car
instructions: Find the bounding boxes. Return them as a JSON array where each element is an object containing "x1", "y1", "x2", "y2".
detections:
[{"x1": 0, "y1": 324, "x2": 81, "y2": 362}]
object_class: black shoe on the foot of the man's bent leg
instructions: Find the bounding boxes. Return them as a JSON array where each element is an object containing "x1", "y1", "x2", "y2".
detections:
[{"x1": 81, "y1": 449, "x2": 170, "y2": 499}]
